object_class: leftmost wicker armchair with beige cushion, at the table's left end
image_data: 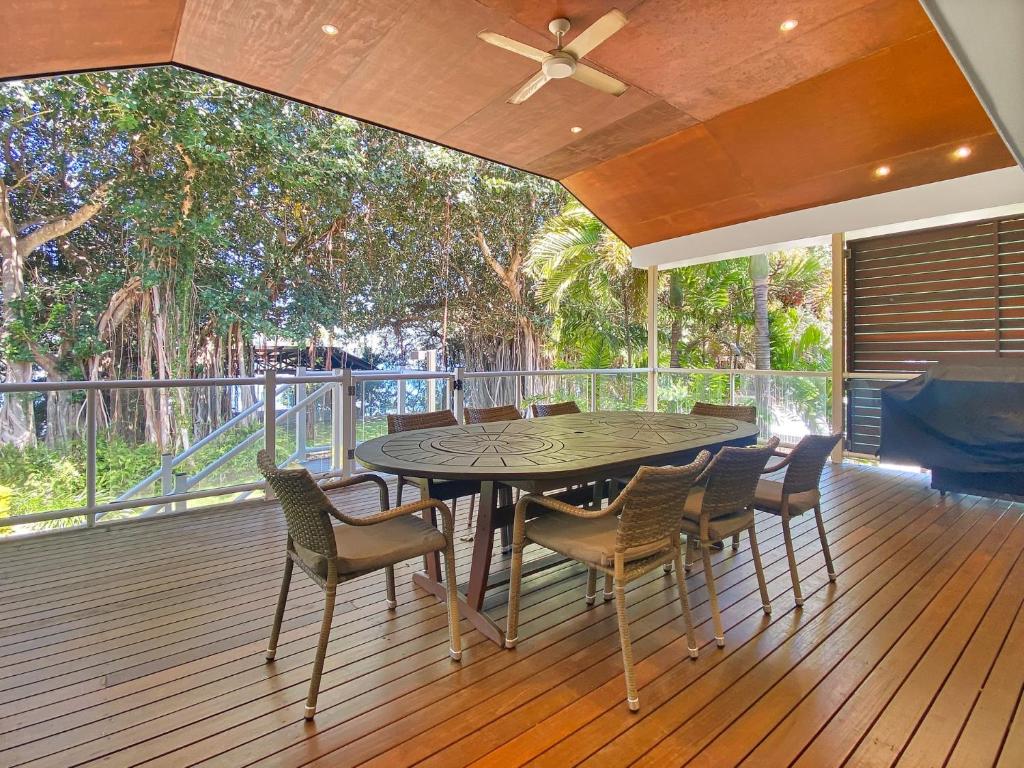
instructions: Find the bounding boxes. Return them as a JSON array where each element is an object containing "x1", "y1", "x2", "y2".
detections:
[{"x1": 257, "y1": 451, "x2": 462, "y2": 720}]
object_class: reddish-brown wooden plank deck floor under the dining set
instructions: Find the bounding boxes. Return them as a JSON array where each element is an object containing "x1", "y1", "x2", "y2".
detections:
[{"x1": 0, "y1": 465, "x2": 1024, "y2": 768}]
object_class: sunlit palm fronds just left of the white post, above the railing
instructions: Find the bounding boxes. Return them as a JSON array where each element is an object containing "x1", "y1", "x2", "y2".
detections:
[{"x1": 526, "y1": 200, "x2": 646, "y2": 368}]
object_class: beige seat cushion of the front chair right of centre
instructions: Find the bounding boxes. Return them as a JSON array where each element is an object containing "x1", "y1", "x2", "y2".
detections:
[{"x1": 526, "y1": 512, "x2": 670, "y2": 566}]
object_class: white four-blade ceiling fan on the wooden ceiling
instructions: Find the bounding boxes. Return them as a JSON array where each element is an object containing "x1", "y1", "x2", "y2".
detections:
[{"x1": 477, "y1": 8, "x2": 627, "y2": 104}]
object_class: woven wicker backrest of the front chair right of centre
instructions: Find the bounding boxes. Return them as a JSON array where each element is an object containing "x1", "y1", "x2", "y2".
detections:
[{"x1": 615, "y1": 451, "x2": 711, "y2": 552}]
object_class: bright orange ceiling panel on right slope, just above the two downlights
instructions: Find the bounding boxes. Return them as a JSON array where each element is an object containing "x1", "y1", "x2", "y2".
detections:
[{"x1": 705, "y1": 32, "x2": 991, "y2": 188}]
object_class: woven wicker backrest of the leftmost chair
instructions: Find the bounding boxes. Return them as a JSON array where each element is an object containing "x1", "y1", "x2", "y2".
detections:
[{"x1": 256, "y1": 451, "x2": 338, "y2": 559}]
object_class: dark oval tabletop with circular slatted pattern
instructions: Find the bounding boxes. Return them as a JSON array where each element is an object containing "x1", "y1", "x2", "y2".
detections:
[{"x1": 355, "y1": 411, "x2": 758, "y2": 480}]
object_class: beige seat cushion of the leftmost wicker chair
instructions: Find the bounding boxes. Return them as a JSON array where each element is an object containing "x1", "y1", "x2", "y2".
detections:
[{"x1": 295, "y1": 515, "x2": 446, "y2": 578}]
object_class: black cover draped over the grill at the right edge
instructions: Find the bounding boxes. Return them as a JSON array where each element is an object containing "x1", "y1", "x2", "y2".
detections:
[{"x1": 879, "y1": 358, "x2": 1024, "y2": 494}]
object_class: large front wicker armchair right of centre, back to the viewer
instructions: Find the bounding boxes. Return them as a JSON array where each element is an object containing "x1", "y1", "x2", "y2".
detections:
[{"x1": 505, "y1": 451, "x2": 711, "y2": 712}]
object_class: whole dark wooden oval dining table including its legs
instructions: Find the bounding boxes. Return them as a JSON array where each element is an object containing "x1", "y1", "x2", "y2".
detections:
[{"x1": 355, "y1": 411, "x2": 758, "y2": 645}]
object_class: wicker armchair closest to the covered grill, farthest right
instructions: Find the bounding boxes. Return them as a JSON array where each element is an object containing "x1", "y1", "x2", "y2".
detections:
[{"x1": 754, "y1": 434, "x2": 843, "y2": 605}]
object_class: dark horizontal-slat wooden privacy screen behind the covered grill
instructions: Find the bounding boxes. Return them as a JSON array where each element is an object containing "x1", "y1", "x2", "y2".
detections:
[{"x1": 846, "y1": 216, "x2": 1024, "y2": 454}]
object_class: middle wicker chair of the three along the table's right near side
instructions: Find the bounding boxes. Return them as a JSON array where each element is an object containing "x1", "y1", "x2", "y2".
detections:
[{"x1": 682, "y1": 437, "x2": 778, "y2": 647}]
